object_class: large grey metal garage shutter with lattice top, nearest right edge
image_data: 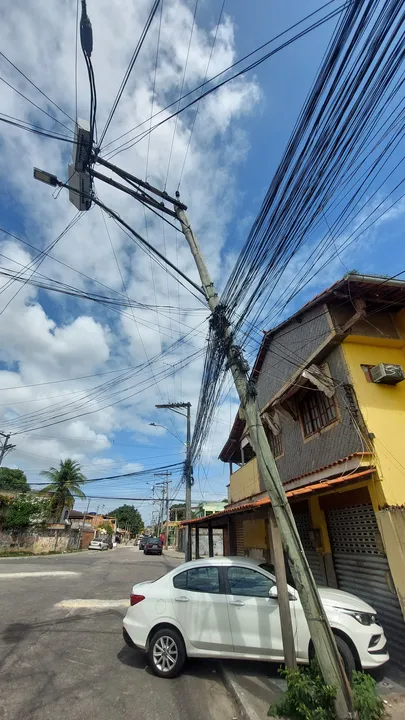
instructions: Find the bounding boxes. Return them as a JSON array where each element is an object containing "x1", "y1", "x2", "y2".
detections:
[{"x1": 326, "y1": 504, "x2": 405, "y2": 667}]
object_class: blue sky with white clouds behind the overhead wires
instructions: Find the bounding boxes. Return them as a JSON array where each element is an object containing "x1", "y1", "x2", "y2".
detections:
[{"x1": 0, "y1": 0, "x2": 405, "y2": 521}]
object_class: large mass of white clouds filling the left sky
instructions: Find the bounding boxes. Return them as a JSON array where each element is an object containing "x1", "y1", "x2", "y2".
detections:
[{"x1": 0, "y1": 0, "x2": 261, "y2": 496}]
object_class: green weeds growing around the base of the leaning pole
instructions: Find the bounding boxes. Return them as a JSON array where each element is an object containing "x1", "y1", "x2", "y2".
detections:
[{"x1": 268, "y1": 660, "x2": 384, "y2": 720}]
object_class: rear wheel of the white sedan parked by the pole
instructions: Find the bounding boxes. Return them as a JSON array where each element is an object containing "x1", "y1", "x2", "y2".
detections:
[{"x1": 148, "y1": 628, "x2": 186, "y2": 678}]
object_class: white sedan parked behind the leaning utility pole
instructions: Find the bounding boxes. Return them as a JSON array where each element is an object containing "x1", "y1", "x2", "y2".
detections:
[{"x1": 123, "y1": 557, "x2": 389, "y2": 678}]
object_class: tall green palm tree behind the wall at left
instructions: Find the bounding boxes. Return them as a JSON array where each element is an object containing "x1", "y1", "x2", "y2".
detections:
[{"x1": 41, "y1": 458, "x2": 87, "y2": 522}]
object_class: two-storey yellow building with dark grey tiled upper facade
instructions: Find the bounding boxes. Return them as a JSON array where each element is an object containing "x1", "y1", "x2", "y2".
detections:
[{"x1": 186, "y1": 273, "x2": 405, "y2": 666}]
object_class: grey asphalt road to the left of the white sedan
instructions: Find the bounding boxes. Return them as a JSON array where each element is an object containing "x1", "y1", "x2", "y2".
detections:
[{"x1": 0, "y1": 547, "x2": 237, "y2": 720}]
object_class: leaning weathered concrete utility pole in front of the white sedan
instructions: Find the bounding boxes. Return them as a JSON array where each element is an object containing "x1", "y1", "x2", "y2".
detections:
[{"x1": 174, "y1": 204, "x2": 355, "y2": 720}]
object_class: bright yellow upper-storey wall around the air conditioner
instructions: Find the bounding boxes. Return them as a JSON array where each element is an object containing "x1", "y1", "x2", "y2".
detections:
[{"x1": 342, "y1": 335, "x2": 405, "y2": 505}]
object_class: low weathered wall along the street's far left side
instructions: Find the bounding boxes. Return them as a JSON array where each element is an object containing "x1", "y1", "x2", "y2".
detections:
[{"x1": 0, "y1": 529, "x2": 80, "y2": 555}]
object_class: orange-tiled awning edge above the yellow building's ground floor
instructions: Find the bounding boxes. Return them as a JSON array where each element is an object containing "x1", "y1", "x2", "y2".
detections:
[{"x1": 181, "y1": 468, "x2": 375, "y2": 526}]
